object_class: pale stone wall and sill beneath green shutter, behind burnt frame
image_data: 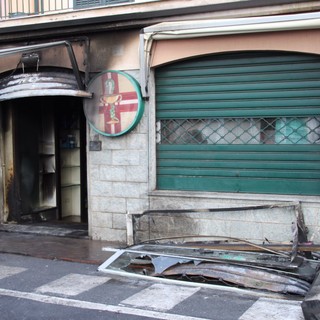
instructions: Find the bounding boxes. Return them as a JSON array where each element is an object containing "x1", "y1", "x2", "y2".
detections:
[{"x1": 141, "y1": 192, "x2": 320, "y2": 243}]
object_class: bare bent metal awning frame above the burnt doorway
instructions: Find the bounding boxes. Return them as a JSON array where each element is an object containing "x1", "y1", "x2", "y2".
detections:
[{"x1": 0, "y1": 40, "x2": 85, "y2": 91}]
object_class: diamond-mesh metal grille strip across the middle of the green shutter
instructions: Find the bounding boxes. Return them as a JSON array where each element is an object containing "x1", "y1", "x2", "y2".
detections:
[{"x1": 157, "y1": 117, "x2": 320, "y2": 145}]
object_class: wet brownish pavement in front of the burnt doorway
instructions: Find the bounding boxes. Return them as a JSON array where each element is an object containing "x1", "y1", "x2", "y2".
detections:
[{"x1": 0, "y1": 224, "x2": 117, "y2": 265}]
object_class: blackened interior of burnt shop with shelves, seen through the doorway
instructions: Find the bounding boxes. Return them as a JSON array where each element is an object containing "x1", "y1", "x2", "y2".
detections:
[{"x1": 8, "y1": 96, "x2": 88, "y2": 227}]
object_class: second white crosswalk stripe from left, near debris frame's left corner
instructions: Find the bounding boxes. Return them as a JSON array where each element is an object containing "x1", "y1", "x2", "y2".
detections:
[{"x1": 36, "y1": 273, "x2": 110, "y2": 296}]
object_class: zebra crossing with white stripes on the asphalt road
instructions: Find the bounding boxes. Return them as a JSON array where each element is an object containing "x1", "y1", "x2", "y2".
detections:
[{"x1": 0, "y1": 264, "x2": 304, "y2": 320}]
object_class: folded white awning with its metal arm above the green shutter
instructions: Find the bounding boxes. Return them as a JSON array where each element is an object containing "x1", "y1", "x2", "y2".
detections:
[{"x1": 139, "y1": 12, "x2": 320, "y2": 97}]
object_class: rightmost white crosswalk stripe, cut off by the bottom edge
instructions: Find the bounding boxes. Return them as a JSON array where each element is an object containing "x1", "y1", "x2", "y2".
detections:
[{"x1": 239, "y1": 298, "x2": 304, "y2": 320}]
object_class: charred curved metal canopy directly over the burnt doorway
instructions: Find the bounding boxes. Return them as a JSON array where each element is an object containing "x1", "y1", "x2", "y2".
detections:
[{"x1": 0, "y1": 71, "x2": 91, "y2": 101}]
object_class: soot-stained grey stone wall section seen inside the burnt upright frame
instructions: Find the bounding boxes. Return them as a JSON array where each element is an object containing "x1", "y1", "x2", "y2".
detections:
[{"x1": 134, "y1": 206, "x2": 296, "y2": 243}]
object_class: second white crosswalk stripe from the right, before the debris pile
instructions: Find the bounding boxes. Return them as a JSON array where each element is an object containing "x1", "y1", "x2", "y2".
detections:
[{"x1": 122, "y1": 284, "x2": 200, "y2": 311}]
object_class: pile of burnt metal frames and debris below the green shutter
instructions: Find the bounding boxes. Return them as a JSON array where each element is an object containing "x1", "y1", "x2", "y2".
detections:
[{"x1": 99, "y1": 204, "x2": 320, "y2": 299}]
